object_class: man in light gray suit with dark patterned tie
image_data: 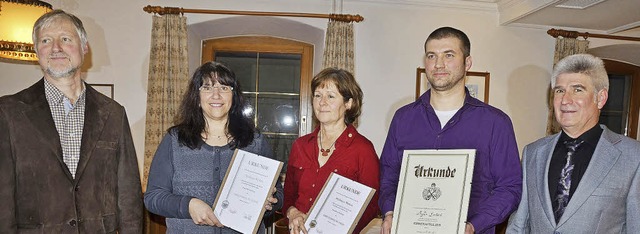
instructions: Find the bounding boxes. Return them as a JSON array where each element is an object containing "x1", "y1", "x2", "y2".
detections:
[{"x1": 507, "y1": 54, "x2": 640, "y2": 233}]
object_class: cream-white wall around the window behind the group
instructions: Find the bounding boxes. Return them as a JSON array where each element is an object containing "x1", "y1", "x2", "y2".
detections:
[{"x1": 0, "y1": 0, "x2": 554, "y2": 177}]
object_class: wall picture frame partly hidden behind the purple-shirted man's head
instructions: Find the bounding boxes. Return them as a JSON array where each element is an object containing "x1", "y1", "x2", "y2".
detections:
[{"x1": 416, "y1": 67, "x2": 491, "y2": 104}]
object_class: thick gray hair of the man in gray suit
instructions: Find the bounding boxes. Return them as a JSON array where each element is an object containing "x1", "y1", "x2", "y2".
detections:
[{"x1": 551, "y1": 54, "x2": 609, "y2": 92}]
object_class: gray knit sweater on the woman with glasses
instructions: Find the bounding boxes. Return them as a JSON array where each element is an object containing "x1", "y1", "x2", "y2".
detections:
[{"x1": 144, "y1": 132, "x2": 283, "y2": 233}]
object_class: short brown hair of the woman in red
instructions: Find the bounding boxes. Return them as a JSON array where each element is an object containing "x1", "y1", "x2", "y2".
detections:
[{"x1": 311, "y1": 67, "x2": 363, "y2": 125}]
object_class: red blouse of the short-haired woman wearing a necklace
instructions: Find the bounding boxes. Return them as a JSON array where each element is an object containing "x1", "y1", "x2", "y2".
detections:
[{"x1": 282, "y1": 125, "x2": 380, "y2": 233}]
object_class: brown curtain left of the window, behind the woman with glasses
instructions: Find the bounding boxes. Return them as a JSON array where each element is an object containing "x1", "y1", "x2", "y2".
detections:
[{"x1": 142, "y1": 14, "x2": 189, "y2": 191}]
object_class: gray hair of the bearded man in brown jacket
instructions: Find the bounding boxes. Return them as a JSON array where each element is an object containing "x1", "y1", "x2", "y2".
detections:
[{"x1": 31, "y1": 10, "x2": 87, "y2": 52}]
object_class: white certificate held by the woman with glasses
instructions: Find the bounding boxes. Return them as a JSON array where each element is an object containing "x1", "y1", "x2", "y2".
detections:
[{"x1": 213, "y1": 150, "x2": 282, "y2": 233}]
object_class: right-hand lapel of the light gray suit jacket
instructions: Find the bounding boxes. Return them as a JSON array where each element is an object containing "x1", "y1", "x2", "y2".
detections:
[{"x1": 558, "y1": 125, "x2": 621, "y2": 226}]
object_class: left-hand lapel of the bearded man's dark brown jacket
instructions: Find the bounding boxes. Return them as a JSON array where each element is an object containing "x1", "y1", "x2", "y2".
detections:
[{"x1": 22, "y1": 79, "x2": 73, "y2": 180}]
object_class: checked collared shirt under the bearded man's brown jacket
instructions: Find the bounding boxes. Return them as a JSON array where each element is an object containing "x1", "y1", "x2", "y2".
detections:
[{"x1": 44, "y1": 79, "x2": 87, "y2": 178}]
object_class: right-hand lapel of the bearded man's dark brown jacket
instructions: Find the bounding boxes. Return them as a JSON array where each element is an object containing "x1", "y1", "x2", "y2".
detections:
[{"x1": 76, "y1": 87, "x2": 109, "y2": 180}]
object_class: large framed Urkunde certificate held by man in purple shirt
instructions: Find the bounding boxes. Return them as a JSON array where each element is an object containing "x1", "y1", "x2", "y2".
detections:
[{"x1": 391, "y1": 149, "x2": 476, "y2": 234}]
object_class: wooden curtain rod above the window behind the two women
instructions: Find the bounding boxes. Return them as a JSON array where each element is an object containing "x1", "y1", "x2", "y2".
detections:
[{"x1": 142, "y1": 5, "x2": 364, "y2": 23}]
